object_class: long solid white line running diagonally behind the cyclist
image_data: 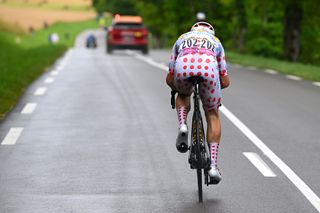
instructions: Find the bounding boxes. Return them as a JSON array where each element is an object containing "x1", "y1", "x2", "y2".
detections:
[{"x1": 127, "y1": 50, "x2": 320, "y2": 212}]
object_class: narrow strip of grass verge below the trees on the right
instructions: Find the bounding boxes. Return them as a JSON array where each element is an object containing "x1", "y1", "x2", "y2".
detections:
[{"x1": 226, "y1": 52, "x2": 320, "y2": 82}]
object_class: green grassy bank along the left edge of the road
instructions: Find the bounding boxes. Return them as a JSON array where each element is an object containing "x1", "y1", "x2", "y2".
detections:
[{"x1": 0, "y1": 20, "x2": 98, "y2": 120}]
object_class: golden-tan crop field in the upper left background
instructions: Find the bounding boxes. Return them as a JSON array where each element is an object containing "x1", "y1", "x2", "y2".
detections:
[{"x1": 0, "y1": 0, "x2": 96, "y2": 31}]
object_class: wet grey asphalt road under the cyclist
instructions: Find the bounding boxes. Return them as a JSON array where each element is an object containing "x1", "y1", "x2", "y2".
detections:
[{"x1": 0, "y1": 29, "x2": 320, "y2": 213}]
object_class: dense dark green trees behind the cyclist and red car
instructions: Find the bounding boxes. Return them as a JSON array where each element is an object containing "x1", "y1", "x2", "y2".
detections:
[{"x1": 92, "y1": 0, "x2": 320, "y2": 64}]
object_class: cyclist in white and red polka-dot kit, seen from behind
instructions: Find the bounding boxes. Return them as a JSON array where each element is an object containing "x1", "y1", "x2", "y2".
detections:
[{"x1": 166, "y1": 22, "x2": 230, "y2": 183}]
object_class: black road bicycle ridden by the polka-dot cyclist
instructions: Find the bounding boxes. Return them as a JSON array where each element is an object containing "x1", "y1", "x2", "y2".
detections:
[{"x1": 171, "y1": 76, "x2": 217, "y2": 203}]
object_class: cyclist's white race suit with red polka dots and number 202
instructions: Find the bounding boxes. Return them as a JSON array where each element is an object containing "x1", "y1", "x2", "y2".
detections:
[{"x1": 169, "y1": 26, "x2": 227, "y2": 110}]
